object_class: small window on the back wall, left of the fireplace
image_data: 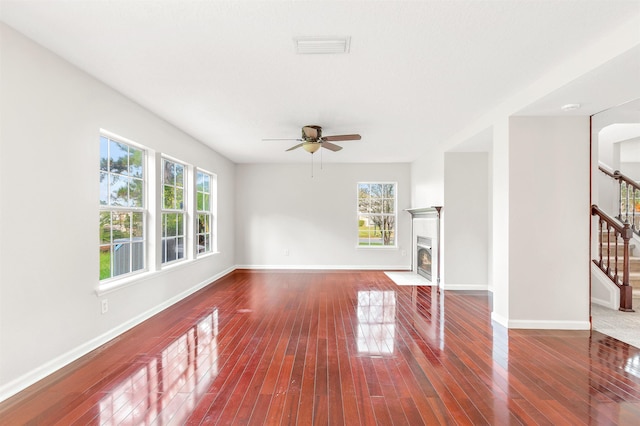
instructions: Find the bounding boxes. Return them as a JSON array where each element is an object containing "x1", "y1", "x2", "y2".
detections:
[{"x1": 358, "y1": 183, "x2": 396, "y2": 247}]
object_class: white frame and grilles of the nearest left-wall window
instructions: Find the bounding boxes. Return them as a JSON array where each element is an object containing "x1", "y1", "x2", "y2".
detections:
[{"x1": 98, "y1": 130, "x2": 149, "y2": 287}]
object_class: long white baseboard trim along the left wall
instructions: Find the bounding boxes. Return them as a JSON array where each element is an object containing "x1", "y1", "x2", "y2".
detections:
[{"x1": 0, "y1": 266, "x2": 236, "y2": 402}]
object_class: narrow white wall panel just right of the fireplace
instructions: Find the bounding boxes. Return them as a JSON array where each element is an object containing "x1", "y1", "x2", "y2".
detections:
[{"x1": 443, "y1": 152, "x2": 489, "y2": 290}]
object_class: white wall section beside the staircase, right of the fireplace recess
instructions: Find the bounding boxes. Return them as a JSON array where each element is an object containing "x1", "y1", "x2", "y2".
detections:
[{"x1": 508, "y1": 117, "x2": 591, "y2": 329}]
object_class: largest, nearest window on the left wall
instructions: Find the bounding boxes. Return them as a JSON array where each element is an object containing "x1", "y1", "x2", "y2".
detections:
[{"x1": 99, "y1": 136, "x2": 146, "y2": 280}]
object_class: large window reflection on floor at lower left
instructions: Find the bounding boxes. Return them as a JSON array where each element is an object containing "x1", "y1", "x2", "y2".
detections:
[{"x1": 99, "y1": 309, "x2": 218, "y2": 425}]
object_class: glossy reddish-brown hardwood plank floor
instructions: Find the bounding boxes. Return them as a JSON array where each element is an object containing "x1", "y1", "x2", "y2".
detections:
[{"x1": 0, "y1": 270, "x2": 640, "y2": 425}]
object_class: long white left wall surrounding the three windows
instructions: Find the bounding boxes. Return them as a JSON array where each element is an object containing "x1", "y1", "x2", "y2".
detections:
[{"x1": 0, "y1": 24, "x2": 235, "y2": 399}]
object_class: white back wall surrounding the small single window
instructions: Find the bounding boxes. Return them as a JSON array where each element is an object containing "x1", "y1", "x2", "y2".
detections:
[{"x1": 236, "y1": 163, "x2": 411, "y2": 269}]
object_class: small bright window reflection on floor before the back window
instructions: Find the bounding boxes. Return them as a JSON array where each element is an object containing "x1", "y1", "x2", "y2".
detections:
[{"x1": 357, "y1": 290, "x2": 396, "y2": 355}]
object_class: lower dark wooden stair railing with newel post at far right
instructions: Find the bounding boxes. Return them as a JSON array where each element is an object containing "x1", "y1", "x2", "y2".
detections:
[{"x1": 591, "y1": 204, "x2": 634, "y2": 312}]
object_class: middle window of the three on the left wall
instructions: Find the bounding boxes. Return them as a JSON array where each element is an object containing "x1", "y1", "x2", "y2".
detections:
[{"x1": 161, "y1": 158, "x2": 186, "y2": 264}]
